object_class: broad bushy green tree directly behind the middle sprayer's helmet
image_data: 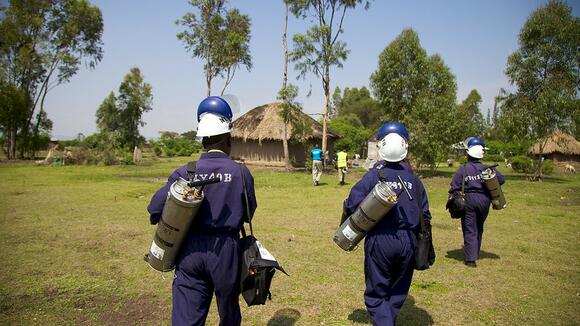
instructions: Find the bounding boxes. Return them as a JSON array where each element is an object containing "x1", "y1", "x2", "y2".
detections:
[{"x1": 371, "y1": 29, "x2": 457, "y2": 169}]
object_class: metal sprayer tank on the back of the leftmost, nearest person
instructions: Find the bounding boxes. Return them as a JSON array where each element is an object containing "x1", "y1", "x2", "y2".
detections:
[{"x1": 144, "y1": 174, "x2": 220, "y2": 272}]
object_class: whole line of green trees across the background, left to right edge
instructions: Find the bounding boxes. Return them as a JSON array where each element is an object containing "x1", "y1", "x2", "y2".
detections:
[{"x1": 0, "y1": 0, "x2": 580, "y2": 173}]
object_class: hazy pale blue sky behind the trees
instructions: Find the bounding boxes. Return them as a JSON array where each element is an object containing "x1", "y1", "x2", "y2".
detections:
[{"x1": 45, "y1": 0, "x2": 580, "y2": 138}]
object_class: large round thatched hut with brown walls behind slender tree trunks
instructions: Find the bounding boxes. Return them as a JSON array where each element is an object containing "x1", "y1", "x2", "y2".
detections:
[{"x1": 231, "y1": 103, "x2": 339, "y2": 167}]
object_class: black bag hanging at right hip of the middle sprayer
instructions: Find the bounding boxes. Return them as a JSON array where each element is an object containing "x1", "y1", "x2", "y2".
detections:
[{"x1": 415, "y1": 177, "x2": 435, "y2": 271}]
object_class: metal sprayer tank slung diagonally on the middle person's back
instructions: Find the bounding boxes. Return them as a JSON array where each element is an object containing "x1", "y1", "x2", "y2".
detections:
[{"x1": 333, "y1": 181, "x2": 397, "y2": 251}]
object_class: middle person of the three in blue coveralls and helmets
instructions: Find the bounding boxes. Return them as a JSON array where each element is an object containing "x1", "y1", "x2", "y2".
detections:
[{"x1": 344, "y1": 122, "x2": 431, "y2": 326}]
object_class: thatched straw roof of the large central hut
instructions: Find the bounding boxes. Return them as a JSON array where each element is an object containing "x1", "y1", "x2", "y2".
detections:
[{"x1": 232, "y1": 102, "x2": 339, "y2": 142}]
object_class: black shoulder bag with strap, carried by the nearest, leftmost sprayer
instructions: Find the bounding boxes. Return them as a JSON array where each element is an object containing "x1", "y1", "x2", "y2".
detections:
[{"x1": 240, "y1": 165, "x2": 288, "y2": 306}]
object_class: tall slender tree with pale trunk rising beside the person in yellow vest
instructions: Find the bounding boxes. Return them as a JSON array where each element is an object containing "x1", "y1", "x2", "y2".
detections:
[{"x1": 288, "y1": 0, "x2": 369, "y2": 163}]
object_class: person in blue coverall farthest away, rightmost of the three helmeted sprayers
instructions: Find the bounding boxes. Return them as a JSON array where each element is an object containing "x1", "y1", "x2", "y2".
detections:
[{"x1": 449, "y1": 137, "x2": 505, "y2": 267}]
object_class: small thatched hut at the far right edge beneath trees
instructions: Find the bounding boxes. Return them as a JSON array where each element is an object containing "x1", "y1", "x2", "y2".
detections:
[{"x1": 528, "y1": 130, "x2": 580, "y2": 162}]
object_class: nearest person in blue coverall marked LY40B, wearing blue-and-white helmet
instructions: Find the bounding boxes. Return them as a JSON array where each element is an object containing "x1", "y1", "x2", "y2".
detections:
[{"x1": 147, "y1": 96, "x2": 257, "y2": 326}]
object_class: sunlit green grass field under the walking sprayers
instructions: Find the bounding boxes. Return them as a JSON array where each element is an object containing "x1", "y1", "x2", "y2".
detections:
[{"x1": 0, "y1": 158, "x2": 580, "y2": 325}]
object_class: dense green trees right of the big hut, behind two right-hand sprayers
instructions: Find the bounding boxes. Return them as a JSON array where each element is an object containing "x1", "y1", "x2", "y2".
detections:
[{"x1": 330, "y1": 1, "x2": 580, "y2": 176}]
